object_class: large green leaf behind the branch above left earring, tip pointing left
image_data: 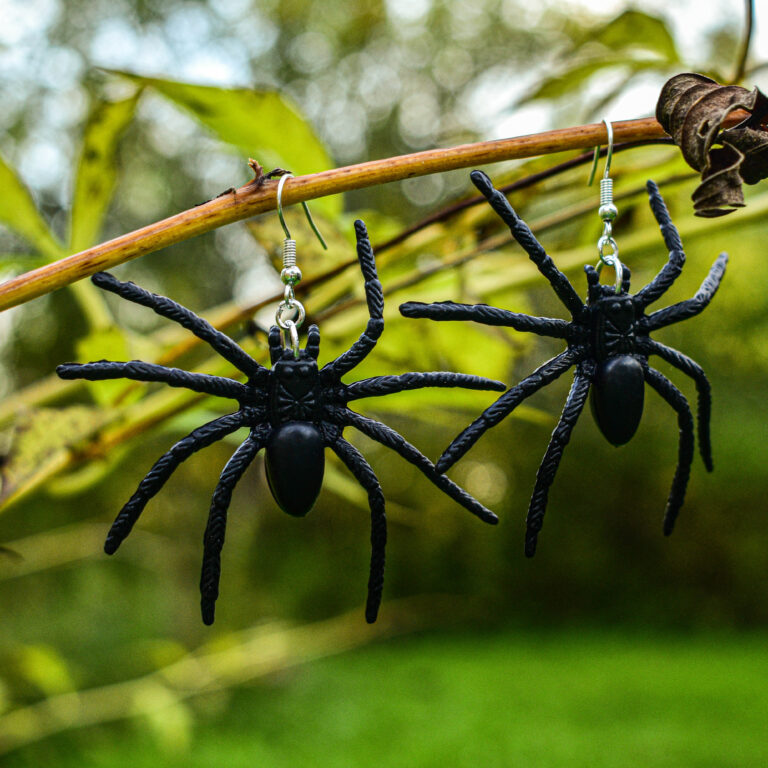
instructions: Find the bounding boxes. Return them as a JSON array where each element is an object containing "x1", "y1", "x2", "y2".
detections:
[{"x1": 109, "y1": 72, "x2": 341, "y2": 216}]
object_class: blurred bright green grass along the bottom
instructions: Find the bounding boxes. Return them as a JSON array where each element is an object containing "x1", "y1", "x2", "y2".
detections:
[{"x1": 4, "y1": 631, "x2": 768, "y2": 768}]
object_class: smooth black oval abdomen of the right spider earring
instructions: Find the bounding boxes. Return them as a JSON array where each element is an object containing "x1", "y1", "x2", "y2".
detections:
[{"x1": 589, "y1": 355, "x2": 645, "y2": 445}]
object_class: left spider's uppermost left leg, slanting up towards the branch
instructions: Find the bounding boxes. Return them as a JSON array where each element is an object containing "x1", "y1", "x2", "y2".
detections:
[{"x1": 91, "y1": 272, "x2": 267, "y2": 377}]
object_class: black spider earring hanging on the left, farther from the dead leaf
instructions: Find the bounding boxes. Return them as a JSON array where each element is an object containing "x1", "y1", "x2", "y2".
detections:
[{"x1": 56, "y1": 177, "x2": 505, "y2": 624}]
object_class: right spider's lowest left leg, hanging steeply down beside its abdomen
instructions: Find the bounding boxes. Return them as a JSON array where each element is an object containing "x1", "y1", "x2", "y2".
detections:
[{"x1": 525, "y1": 360, "x2": 595, "y2": 557}]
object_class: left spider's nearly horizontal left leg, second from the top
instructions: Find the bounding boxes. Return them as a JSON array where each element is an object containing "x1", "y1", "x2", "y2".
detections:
[{"x1": 56, "y1": 360, "x2": 248, "y2": 400}]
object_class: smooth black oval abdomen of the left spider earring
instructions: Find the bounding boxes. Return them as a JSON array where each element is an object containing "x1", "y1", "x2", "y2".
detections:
[{"x1": 264, "y1": 421, "x2": 325, "y2": 517}]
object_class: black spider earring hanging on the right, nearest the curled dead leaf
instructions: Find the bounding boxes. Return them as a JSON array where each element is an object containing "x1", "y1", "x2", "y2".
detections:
[{"x1": 400, "y1": 123, "x2": 728, "y2": 557}]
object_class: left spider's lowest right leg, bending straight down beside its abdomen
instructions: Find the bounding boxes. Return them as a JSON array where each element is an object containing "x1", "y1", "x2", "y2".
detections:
[{"x1": 330, "y1": 437, "x2": 387, "y2": 624}]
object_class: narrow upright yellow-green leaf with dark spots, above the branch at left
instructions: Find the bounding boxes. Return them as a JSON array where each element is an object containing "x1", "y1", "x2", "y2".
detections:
[{"x1": 69, "y1": 90, "x2": 141, "y2": 253}]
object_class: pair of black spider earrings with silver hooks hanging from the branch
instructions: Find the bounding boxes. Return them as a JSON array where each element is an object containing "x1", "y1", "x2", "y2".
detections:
[{"x1": 57, "y1": 129, "x2": 727, "y2": 624}]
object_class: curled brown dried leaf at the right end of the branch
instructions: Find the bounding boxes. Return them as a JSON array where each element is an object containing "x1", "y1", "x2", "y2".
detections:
[{"x1": 656, "y1": 72, "x2": 768, "y2": 218}]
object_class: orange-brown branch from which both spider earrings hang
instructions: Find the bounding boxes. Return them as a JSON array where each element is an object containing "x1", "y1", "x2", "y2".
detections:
[{"x1": 0, "y1": 112, "x2": 744, "y2": 311}]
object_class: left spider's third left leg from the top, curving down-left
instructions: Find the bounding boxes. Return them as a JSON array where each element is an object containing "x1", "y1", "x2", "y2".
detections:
[{"x1": 104, "y1": 412, "x2": 246, "y2": 555}]
